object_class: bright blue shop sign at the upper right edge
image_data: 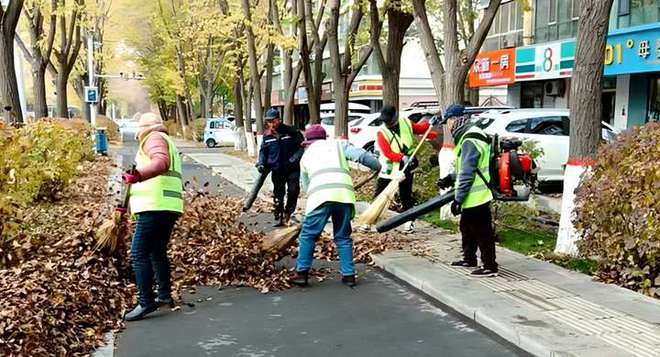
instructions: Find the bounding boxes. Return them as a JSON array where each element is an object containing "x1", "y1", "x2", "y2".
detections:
[{"x1": 605, "y1": 23, "x2": 660, "y2": 76}]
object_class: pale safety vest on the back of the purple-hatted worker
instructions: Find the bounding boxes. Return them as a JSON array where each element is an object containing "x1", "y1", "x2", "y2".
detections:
[{"x1": 300, "y1": 140, "x2": 355, "y2": 214}]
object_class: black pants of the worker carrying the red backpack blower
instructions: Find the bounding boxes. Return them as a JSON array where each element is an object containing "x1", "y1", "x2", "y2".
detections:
[{"x1": 460, "y1": 202, "x2": 497, "y2": 270}]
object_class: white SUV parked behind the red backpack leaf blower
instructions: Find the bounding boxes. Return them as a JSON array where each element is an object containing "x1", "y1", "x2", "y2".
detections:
[{"x1": 473, "y1": 109, "x2": 619, "y2": 181}]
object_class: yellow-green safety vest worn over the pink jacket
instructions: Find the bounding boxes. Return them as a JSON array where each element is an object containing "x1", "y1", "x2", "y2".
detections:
[{"x1": 130, "y1": 132, "x2": 183, "y2": 213}]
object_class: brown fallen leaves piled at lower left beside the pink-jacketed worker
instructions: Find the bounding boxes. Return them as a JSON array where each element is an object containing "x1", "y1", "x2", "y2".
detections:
[{"x1": 0, "y1": 160, "x2": 132, "y2": 356}]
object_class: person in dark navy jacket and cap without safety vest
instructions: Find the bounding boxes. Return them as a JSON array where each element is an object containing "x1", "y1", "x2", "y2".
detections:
[{"x1": 257, "y1": 108, "x2": 305, "y2": 227}]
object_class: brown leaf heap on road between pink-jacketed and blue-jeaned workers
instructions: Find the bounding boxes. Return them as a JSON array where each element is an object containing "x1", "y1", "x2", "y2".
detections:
[{"x1": 170, "y1": 194, "x2": 289, "y2": 292}]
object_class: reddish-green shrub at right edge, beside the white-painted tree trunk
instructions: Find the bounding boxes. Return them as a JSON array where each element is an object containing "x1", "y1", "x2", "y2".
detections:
[{"x1": 574, "y1": 123, "x2": 660, "y2": 297}]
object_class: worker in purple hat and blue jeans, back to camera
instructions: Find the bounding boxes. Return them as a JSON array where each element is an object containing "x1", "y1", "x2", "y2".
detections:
[{"x1": 289, "y1": 124, "x2": 380, "y2": 287}]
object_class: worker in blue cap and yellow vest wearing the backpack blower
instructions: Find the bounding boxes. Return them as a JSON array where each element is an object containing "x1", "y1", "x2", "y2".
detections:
[{"x1": 439, "y1": 105, "x2": 498, "y2": 277}]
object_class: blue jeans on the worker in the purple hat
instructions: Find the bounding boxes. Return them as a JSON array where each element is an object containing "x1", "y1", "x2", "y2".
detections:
[{"x1": 296, "y1": 202, "x2": 355, "y2": 276}]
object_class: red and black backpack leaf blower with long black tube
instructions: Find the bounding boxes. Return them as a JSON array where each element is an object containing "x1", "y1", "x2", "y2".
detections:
[{"x1": 376, "y1": 135, "x2": 538, "y2": 233}]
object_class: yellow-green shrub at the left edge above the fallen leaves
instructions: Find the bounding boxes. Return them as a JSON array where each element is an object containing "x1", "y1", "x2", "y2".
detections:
[{"x1": 0, "y1": 120, "x2": 94, "y2": 266}]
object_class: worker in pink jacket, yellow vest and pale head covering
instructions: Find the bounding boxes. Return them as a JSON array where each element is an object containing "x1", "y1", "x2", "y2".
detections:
[{"x1": 122, "y1": 113, "x2": 183, "y2": 321}]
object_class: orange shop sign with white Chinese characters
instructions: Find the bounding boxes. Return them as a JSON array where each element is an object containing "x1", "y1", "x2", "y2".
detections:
[{"x1": 468, "y1": 48, "x2": 516, "y2": 88}]
